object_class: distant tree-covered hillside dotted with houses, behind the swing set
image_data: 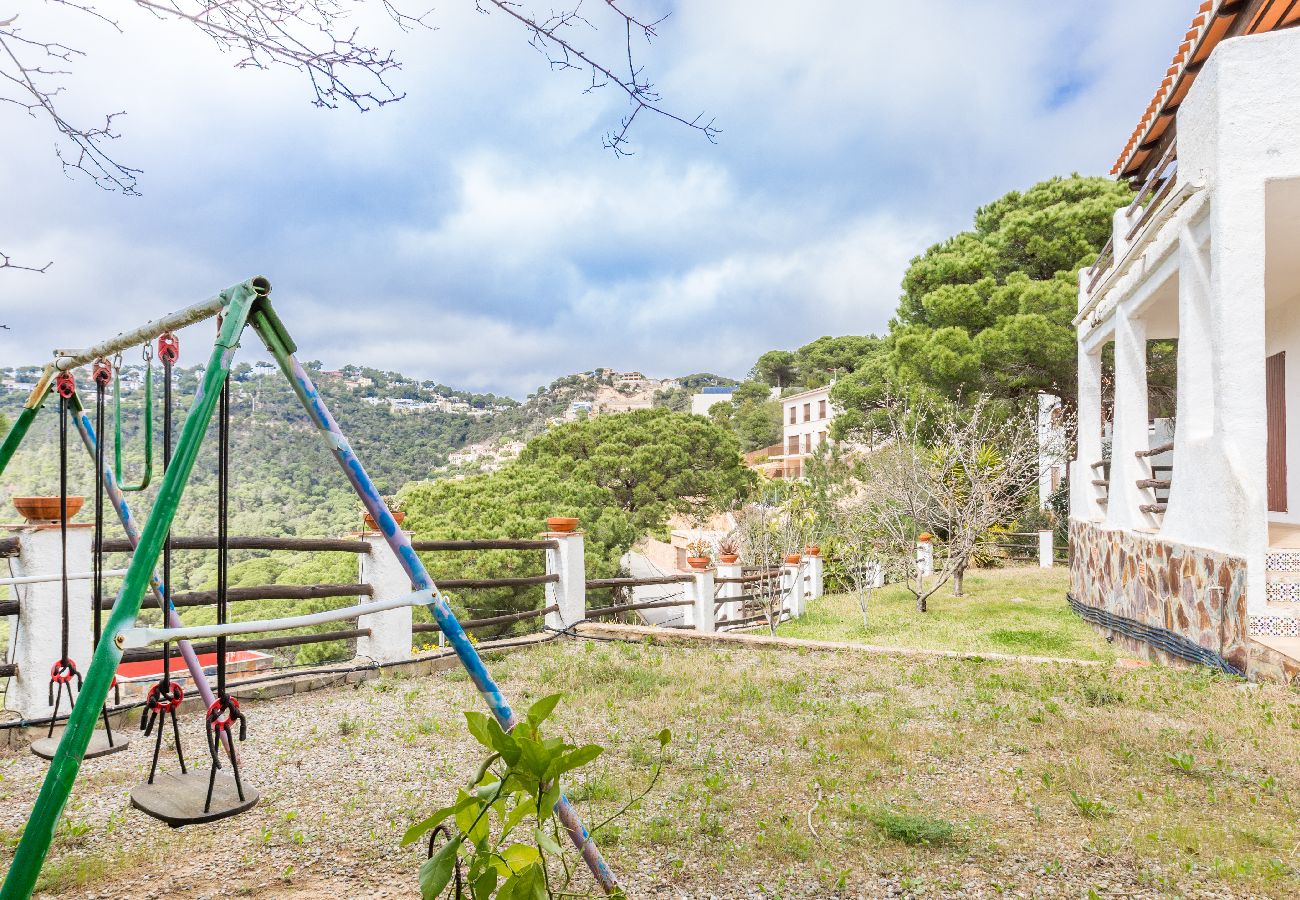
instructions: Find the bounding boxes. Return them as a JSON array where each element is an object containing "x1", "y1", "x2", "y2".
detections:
[{"x1": 0, "y1": 363, "x2": 725, "y2": 589}]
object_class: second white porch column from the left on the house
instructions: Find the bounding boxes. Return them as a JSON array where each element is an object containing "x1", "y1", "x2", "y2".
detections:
[{"x1": 1106, "y1": 311, "x2": 1157, "y2": 528}]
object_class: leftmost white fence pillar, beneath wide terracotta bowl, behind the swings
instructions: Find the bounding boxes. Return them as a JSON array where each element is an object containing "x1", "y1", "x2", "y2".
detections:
[{"x1": 5, "y1": 524, "x2": 94, "y2": 719}]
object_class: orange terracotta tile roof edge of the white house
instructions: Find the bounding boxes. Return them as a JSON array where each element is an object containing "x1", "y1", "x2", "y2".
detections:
[{"x1": 1110, "y1": 0, "x2": 1300, "y2": 177}]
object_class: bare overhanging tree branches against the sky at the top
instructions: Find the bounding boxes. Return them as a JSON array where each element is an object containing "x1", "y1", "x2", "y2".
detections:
[{"x1": 0, "y1": 0, "x2": 719, "y2": 272}]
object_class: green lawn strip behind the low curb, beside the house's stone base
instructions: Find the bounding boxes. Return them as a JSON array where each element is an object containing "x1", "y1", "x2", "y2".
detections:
[{"x1": 777, "y1": 567, "x2": 1115, "y2": 661}]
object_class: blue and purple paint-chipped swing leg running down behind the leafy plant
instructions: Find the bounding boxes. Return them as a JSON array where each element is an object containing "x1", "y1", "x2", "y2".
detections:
[{"x1": 250, "y1": 309, "x2": 619, "y2": 893}]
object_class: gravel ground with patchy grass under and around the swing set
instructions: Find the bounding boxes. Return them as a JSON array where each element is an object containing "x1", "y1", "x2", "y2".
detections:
[{"x1": 0, "y1": 640, "x2": 1300, "y2": 900}]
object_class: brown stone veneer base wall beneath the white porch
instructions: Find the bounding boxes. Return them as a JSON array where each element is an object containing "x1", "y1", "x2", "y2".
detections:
[{"x1": 1070, "y1": 519, "x2": 1252, "y2": 671}]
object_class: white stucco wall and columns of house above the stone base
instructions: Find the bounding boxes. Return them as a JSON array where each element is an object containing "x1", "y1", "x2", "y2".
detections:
[{"x1": 1073, "y1": 29, "x2": 1300, "y2": 614}]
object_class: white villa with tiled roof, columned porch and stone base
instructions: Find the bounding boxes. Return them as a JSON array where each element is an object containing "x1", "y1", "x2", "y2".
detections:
[{"x1": 1070, "y1": 0, "x2": 1300, "y2": 682}]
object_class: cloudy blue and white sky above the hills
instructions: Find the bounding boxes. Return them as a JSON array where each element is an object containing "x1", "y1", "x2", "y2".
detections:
[{"x1": 0, "y1": 0, "x2": 1196, "y2": 395}]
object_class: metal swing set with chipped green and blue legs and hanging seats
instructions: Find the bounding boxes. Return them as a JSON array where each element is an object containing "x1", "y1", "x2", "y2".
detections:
[{"x1": 0, "y1": 277, "x2": 618, "y2": 900}]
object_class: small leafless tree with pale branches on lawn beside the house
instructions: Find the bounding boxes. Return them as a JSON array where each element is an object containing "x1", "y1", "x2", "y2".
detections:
[{"x1": 858, "y1": 395, "x2": 1040, "y2": 613}]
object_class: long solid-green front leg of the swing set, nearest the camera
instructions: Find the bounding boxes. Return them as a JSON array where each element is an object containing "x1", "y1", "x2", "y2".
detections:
[{"x1": 0, "y1": 280, "x2": 270, "y2": 900}]
